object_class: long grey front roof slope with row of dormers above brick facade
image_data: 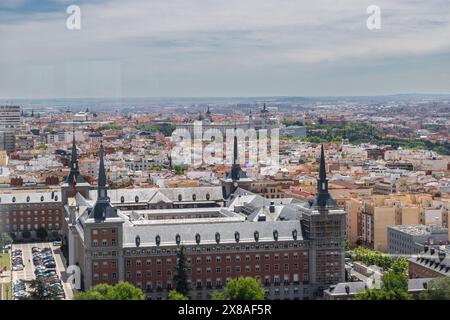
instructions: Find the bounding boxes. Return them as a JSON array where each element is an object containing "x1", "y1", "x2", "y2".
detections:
[{"x1": 123, "y1": 221, "x2": 303, "y2": 247}]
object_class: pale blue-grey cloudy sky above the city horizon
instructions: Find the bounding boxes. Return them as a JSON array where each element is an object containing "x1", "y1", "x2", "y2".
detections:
[{"x1": 0, "y1": 0, "x2": 450, "y2": 99}]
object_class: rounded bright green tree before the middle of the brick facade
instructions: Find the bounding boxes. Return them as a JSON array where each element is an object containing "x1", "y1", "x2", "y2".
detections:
[{"x1": 212, "y1": 277, "x2": 265, "y2": 300}]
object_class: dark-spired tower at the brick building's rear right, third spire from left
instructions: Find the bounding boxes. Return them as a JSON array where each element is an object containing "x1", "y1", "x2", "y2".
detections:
[{"x1": 221, "y1": 128, "x2": 252, "y2": 199}]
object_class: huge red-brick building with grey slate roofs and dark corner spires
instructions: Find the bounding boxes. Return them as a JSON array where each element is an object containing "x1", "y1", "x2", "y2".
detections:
[{"x1": 62, "y1": 143, "x2": 345, "y2": 299}]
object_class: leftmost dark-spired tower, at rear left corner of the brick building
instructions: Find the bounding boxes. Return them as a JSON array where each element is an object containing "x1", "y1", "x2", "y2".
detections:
[{"x1": 61, "y1": 129, "x2": 91, "y2": 204}]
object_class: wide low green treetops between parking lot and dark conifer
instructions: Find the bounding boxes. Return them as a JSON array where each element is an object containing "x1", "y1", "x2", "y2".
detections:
[{"x1": 75, "y1": 281, "x2": 145, "y2": 300}]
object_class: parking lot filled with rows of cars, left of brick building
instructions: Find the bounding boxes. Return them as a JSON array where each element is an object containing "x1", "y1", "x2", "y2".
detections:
[{"x1": 12, "y1": 242, "x2": 73, "y2": 299}]
